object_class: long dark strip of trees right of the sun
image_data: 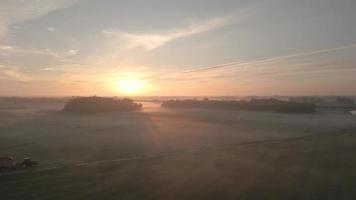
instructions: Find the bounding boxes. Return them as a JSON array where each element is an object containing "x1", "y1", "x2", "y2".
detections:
[{"x1": 162, "y1": 99, "x2": 316, "y2": 113}]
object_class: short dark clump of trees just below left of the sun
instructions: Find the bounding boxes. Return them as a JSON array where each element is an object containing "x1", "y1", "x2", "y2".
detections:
[{"x1": 63, "y1": 96, "x2": 142, "y2": 113}]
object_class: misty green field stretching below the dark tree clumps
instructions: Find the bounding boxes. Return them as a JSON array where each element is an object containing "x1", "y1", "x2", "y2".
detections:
[{"x1": 0, "y1": 101, "x2": 356, "y2": 200}]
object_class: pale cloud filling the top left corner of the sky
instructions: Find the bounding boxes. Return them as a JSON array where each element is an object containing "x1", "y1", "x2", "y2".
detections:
[{"x1": 0, "y1": 0, "x2": 77, "y2": 42}]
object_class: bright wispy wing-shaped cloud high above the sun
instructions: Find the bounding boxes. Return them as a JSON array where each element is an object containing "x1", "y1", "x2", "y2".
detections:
[{"x1": 102, "y1": 16, "x2": 235, "y2": 50}]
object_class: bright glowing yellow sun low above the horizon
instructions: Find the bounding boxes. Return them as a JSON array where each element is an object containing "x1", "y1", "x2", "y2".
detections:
[{"x1": 117, "y1": 79, "x2": 145, "y2": 95}]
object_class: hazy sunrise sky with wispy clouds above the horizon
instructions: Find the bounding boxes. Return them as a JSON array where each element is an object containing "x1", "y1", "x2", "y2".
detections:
[{"x1": 0, "y1": 0, "x2": 356, "y2": 96}]
